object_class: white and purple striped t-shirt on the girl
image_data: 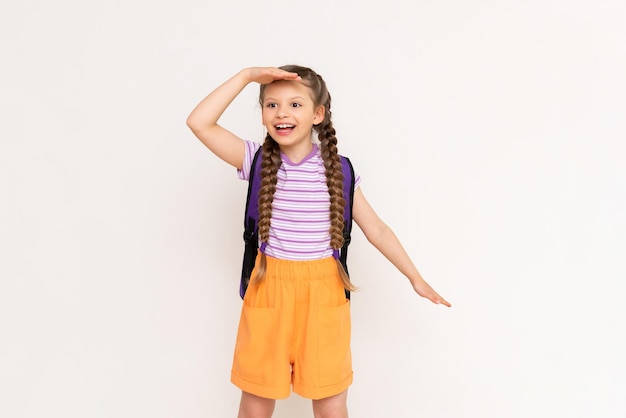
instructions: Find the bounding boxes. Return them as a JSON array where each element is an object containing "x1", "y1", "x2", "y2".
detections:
[{"x1": 237, "y1": 141, "x2": 361, "y2": 260}]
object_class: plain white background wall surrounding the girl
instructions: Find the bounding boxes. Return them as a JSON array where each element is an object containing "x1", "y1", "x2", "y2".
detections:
[{"x1": 0, "y1": 0, "x2": 626, "y2": 418}]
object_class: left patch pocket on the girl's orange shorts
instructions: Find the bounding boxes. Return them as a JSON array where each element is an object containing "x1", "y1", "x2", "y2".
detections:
[{"x1": 233, "y1": 305, "x2": 278, "y2": 384}]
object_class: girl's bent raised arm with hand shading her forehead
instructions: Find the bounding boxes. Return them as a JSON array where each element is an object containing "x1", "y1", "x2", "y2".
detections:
[{"x1": 187, "y1": 67, "x2": 300, "y2": 169}]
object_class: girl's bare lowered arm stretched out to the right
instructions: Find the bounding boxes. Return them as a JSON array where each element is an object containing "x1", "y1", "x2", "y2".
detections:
[{"x1": 352, "y1": 187, "x2": 451, "y2": 307}]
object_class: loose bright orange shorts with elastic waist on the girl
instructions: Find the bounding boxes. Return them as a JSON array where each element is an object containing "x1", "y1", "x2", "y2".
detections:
[{"x1": 231, "y1": 256, "x2": 352, "y2": 399}]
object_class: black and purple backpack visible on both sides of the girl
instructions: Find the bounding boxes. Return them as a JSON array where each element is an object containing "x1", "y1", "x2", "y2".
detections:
[{"x1": 239, "y1": 147, "x2": 354, "y2": 299}]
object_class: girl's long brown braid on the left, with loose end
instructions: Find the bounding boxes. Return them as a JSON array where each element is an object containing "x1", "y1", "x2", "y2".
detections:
[{"x1": 254, "y1": 134, "x2": 282, "y2": 282}]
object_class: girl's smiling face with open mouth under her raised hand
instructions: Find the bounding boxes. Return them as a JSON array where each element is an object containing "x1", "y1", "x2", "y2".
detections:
[{"x1": 262, "y1": 81, "x2": 324, "y2": 153}]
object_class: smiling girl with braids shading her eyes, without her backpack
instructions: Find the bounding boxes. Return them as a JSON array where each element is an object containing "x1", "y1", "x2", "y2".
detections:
[{"x1": 187, "y1": 66, "x2": 450, "y2": 418}]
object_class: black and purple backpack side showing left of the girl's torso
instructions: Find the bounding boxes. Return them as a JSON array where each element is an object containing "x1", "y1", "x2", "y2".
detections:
[{"x1": 239, "y1": 147, "x2": 262, "y2": 299}]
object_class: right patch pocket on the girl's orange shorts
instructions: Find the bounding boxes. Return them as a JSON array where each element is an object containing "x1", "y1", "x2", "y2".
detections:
[{"x1": 318, "y1": 300, "x2": 352, "y2": 386}]
